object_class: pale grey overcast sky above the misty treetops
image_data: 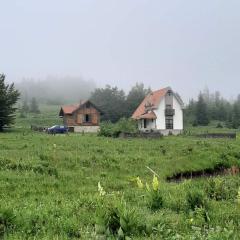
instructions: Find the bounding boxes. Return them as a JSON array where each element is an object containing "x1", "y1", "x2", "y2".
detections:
[{"x1": 0, "y1": 0, "x2": 240, "y2": 99}]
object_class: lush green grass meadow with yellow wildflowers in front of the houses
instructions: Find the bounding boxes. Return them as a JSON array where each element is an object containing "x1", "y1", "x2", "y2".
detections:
[{"x1": 0, "y1": 106, "x2": 240, "y2": 240}]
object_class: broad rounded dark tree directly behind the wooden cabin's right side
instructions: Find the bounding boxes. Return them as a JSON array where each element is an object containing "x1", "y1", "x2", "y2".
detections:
[{"x1": 90, "y1": 85, "x2": 126, "y2": 122}]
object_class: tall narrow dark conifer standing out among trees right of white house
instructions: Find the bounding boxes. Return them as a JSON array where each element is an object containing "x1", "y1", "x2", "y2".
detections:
[{"x1": 196, "y1": 93, "x2": 209, "y2": 126}]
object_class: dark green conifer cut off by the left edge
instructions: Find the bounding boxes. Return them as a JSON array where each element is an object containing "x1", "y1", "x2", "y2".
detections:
[{"x1": 0, "y1": 74, "x2": 20, "y2": 131}]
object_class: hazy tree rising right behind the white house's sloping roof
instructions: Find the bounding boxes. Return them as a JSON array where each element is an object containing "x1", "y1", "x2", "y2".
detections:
[{"x1": 126, "y1": 83, "x2": 151, "y2": 117}]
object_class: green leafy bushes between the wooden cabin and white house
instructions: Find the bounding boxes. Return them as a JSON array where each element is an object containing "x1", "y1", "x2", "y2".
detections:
[{"x1": 99, "y1": 118, "x2": 138, "y2": 137}]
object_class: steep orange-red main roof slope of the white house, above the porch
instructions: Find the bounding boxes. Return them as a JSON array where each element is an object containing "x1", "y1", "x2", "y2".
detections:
[{"x1": 132, "y1": 87, "x2": 171, "y2": 119}]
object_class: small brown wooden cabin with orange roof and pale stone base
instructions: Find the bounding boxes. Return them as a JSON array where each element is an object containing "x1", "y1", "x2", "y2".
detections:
[{"x1": 59, "y1": 100, "x2": 101, "y2": 132}]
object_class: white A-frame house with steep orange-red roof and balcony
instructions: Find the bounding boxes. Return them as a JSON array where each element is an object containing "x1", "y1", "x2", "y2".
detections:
[{"x1": 132, "y1": 87, "x2": 183, "y2": 135}]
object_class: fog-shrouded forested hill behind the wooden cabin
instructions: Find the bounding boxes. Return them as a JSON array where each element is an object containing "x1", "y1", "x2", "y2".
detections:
[{"x1": 16, "y1": 76, "x2": 96, "y2": 105}]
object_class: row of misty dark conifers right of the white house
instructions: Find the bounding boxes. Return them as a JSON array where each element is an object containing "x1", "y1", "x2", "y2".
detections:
[{"x1": 184, "y1": 89, "x2": 240, "y2": 128}]
